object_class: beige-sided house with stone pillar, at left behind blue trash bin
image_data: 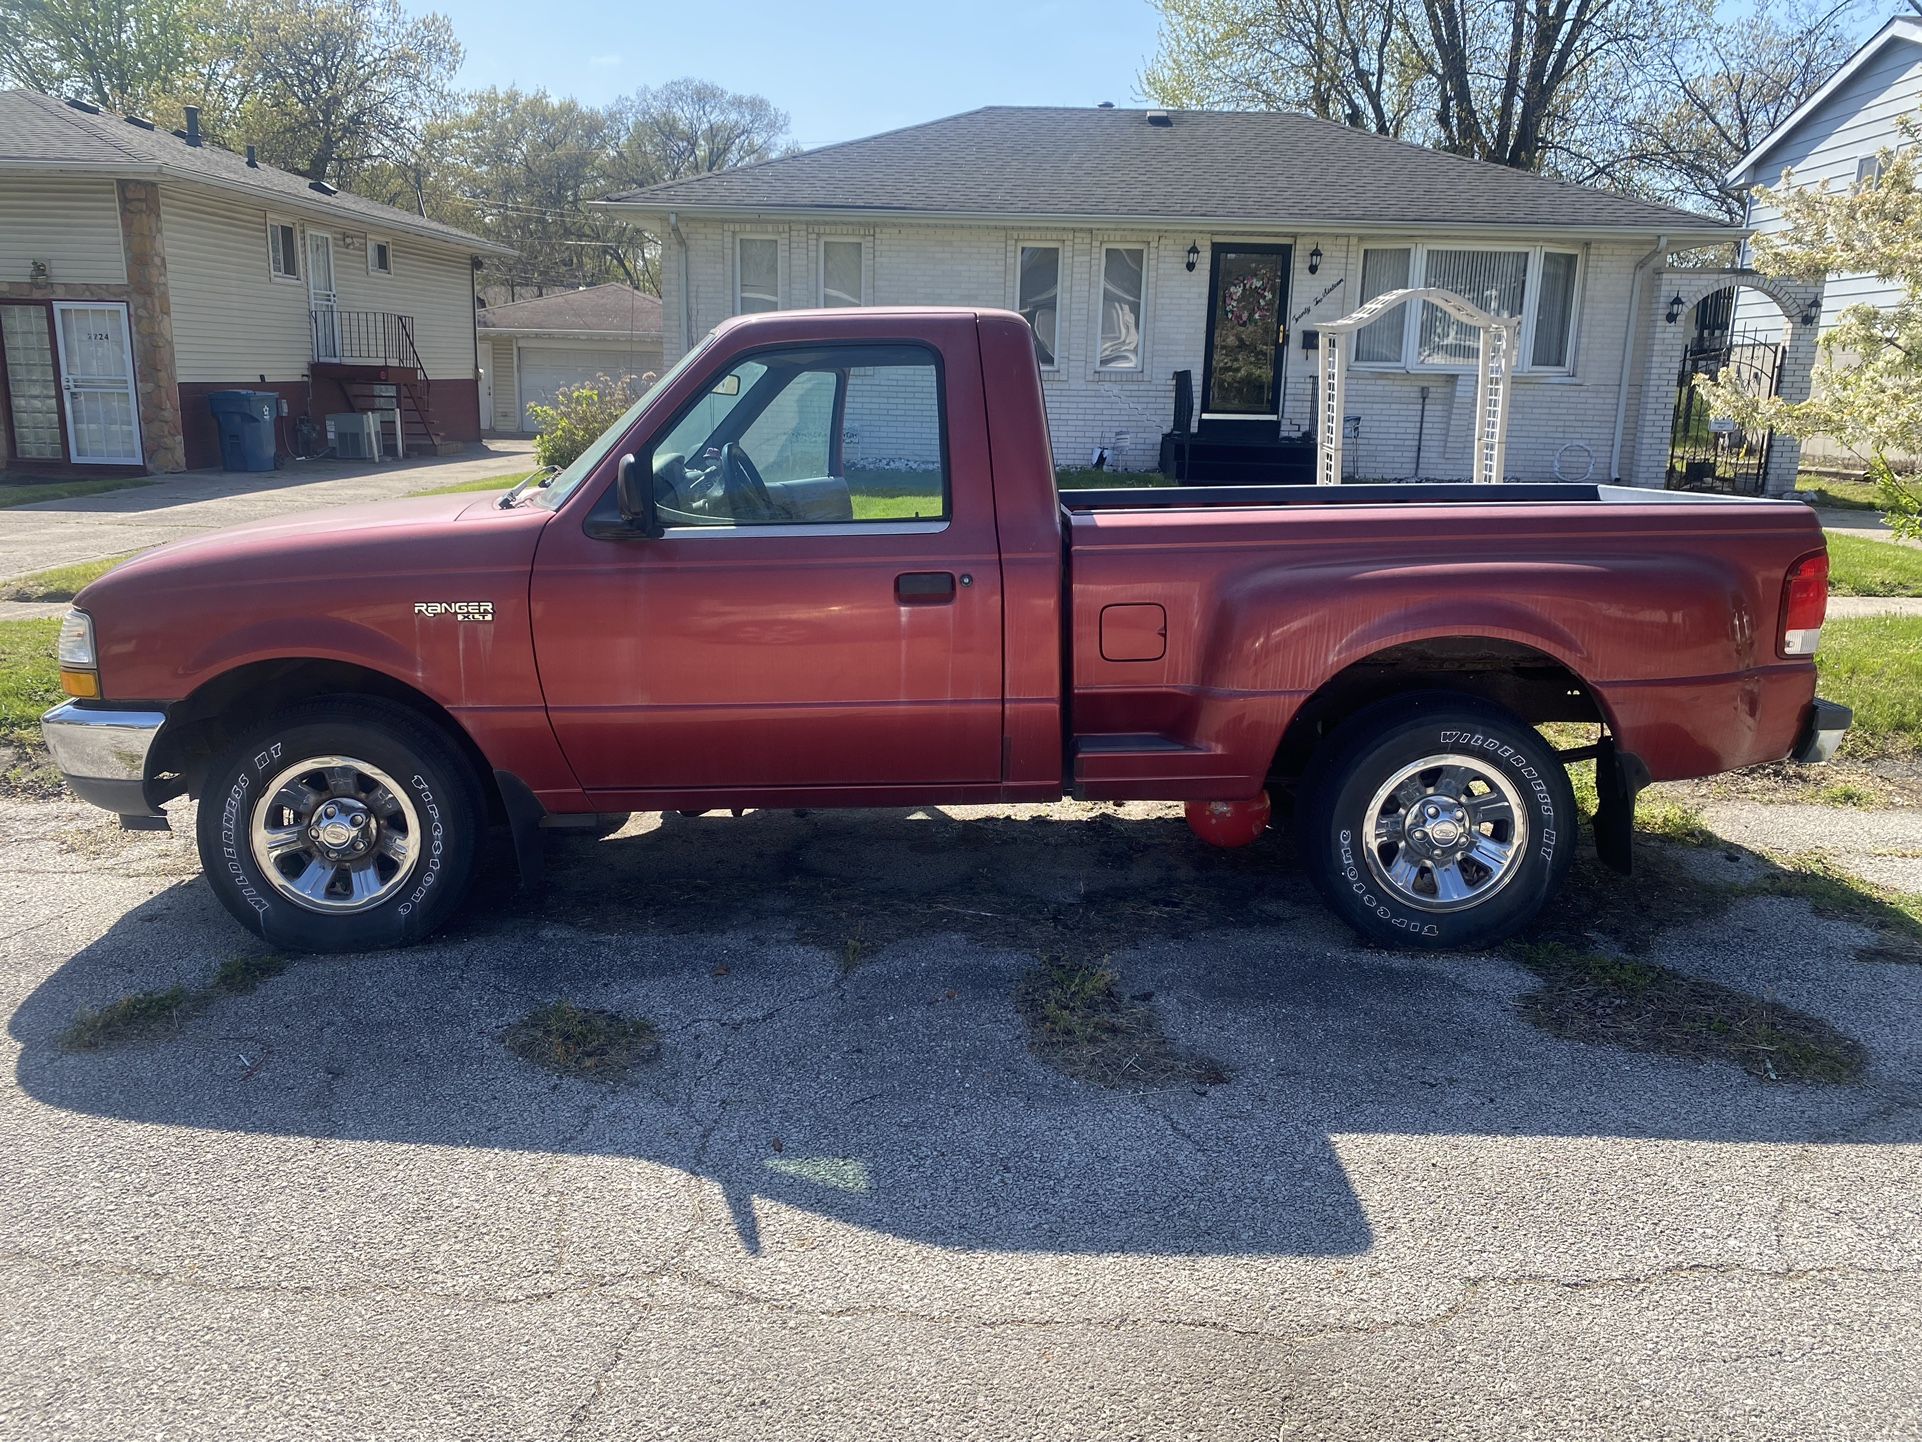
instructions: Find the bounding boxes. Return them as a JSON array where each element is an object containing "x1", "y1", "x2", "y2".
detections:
[{"x1": 0, "y1": 90, "x2": 507, "y2": 471}]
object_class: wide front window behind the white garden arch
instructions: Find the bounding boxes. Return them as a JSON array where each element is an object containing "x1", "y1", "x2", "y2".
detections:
[{"x1": 1355, "y1": 246, "x2": 1582, "y2": 371}]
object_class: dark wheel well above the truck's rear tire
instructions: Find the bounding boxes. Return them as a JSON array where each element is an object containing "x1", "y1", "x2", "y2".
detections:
[{"x1": 1270, "y1": 636, "x2": 1607, "y2": 781}]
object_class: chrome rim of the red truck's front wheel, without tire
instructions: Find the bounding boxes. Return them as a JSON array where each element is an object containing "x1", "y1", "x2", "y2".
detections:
[{"x1": 250, "y1": 756, "x2": 421, "y2": 915}]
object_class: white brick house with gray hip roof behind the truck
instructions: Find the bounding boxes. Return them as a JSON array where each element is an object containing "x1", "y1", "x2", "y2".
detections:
[{"x1": 602, "y1": 108, "x2": 1809, "y2": 490}]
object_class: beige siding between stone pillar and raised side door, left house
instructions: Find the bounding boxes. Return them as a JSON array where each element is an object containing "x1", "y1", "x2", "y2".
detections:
[{"x1": 160, "y1": 185, "x2": 311, "y2": 383}]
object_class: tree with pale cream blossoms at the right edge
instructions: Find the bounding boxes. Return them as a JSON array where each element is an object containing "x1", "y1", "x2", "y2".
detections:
[{"x1": 1697, "y1": 119, "x2": 1922, "y2": 538}]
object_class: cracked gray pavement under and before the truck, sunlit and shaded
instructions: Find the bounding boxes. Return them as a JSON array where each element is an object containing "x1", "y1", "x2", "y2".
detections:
[{"x1": 0, "y1": 802, "x2": 1922, "y2": 1440}]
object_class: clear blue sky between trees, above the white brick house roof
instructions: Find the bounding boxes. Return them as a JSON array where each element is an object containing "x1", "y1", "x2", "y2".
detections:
[{"x1": 447, "y1": 0, "x2": 1157, "y2": 146}]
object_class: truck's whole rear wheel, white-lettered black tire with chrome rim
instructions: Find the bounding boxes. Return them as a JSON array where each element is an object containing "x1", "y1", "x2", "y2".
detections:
[{"x1": 1297, "y1": 692, "x2": 1576, "y2": 950}]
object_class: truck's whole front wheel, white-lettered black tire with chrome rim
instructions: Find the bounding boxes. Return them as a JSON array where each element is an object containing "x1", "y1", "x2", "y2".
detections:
[{"x1": 196, "y1": 698, "x2": 486, "y2": 952}]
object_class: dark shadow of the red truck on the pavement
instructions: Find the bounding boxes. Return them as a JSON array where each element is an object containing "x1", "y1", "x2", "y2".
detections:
[{"x1": 12, "y1": 808, "x2": 1922, "y2": 1256}]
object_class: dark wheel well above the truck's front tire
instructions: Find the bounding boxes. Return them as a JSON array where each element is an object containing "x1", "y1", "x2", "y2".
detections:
[{"x1": 148, "y1": 658, "x2": 502, "y2": 819}]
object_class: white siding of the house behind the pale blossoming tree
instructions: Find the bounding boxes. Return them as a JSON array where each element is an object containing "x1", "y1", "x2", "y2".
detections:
[{"x1": 1736, "y1": 37, "x2": 1922, "y2": 333}]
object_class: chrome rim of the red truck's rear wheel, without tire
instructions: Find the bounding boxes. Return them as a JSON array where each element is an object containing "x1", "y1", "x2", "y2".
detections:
[{"x1": 1367, "y1": 752, "x2": 1528, "y2": 911}]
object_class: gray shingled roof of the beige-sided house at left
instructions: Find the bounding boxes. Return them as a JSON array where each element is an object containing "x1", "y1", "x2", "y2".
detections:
[{"x1": 0, "y1": 90, "x2": 513, "y2": 256}]
